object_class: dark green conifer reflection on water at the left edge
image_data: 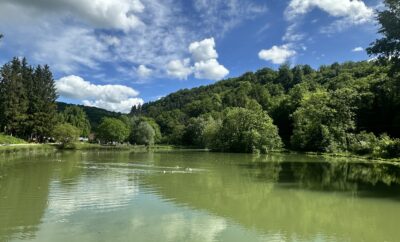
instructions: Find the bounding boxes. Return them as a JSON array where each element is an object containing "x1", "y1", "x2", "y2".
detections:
[{"x1": 0, "y1": 153, "x2": 51, "y2": 240}]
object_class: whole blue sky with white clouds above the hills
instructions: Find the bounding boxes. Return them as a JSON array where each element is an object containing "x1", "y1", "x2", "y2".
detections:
[{"x1": 0, "y1": 0, "x2": 382, "y2": 112}]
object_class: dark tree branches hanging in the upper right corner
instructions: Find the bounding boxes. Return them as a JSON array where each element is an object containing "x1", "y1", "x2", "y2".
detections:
[{"x1": 367, "y1": 0, "x2": 400, "y2": 73}]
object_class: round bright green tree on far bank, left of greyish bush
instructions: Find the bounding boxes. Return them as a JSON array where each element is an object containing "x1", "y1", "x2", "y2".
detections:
[{"x1": 97, "y1": 118, "x2": 130, "y2": 143}]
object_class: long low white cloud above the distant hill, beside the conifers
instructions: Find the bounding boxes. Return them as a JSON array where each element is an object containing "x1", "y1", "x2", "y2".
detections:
[{"x1": 56, "y1": 75, "x2": 144, "y2": 113}]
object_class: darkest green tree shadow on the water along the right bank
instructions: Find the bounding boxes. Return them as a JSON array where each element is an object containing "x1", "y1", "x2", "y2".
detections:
[{"x1": 239, "y1": 157, "x2": 400, "y2": 201}]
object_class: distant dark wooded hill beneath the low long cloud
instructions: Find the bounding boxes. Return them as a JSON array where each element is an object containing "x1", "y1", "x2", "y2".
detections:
[{"x1": 57, "y1": 102, "x2": 122, "y2": 129}]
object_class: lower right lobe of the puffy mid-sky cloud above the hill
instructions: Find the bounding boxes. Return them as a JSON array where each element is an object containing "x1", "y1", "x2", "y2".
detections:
[{"x1": 194, "y1": 59, "x2": 229, "y2": 80}]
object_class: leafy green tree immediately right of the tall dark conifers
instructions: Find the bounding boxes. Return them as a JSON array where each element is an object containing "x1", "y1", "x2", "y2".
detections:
[{"x1": 62, "y1": 106, "x2": 90, "y2": 137}]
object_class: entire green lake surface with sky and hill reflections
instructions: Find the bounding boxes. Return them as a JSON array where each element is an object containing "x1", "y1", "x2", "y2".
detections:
[{"x1": 0, "y1": 151, "x2": 400, "y2": 242}]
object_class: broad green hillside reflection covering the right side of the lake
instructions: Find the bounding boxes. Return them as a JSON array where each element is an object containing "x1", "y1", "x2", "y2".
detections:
[{"x1": 141, "y1": 154, "x2": 400, "y2": 241}]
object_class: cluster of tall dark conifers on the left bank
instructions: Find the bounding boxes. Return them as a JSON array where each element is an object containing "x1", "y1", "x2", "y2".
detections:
[{"x1": 0, "y1": 58, "x2": 57, "y2": 141}]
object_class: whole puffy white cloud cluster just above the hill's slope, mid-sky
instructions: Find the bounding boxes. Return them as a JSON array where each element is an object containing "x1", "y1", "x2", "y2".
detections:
[{"x1": 167, "y1": 38, "x2": 229, "y2": 80}]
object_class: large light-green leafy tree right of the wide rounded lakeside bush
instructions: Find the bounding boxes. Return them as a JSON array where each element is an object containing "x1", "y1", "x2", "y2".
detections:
[{"x1": 291, "y1": 89, "x2": 355, "y2": 151}]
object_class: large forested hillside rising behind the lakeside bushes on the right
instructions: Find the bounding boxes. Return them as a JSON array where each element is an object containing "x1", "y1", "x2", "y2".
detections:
[{"x1": 132, "y1": 61, "x2": 400, "y2": 154}]
